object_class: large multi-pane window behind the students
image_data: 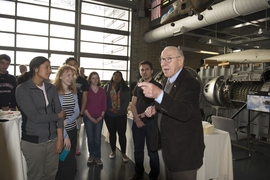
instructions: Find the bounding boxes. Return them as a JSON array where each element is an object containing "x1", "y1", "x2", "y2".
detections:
[{"x1": 0, "y1": 0, "x2": 132, "y2": 82}]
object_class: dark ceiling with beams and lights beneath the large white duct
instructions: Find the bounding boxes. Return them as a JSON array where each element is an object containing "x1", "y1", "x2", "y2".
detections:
[{"x1": 188, "y1": 1, "x2": 270, "y2": 49}]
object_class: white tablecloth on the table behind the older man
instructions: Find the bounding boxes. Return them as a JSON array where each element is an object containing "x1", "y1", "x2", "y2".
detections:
[{"x1": 102, "y1": 118, "x2": 233, "y2": 180}]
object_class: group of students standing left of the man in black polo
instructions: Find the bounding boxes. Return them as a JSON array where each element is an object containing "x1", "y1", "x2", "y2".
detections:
[{"x1": 0, "y1": 55, "x2": 130, "y2": 180}]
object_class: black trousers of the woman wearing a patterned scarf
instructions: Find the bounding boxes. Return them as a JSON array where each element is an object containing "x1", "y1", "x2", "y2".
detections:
[{"x1": 104, "y1": 114, "x2": 127, "y2": 154}]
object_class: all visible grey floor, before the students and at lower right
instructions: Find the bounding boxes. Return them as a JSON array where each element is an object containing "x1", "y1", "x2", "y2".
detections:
[{"x1": 76, "y1": 126, "x2": 270, "y2": 180}]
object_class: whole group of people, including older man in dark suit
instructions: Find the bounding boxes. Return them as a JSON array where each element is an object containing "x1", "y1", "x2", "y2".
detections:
[{"x1": 0, "y1": 46, "x2": 205, "y2": 180}]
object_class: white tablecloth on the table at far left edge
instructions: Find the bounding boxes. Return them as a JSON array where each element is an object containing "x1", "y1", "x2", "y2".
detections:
[{"x1": 0, "y1": 112, "x2": 27, "y2": 180}]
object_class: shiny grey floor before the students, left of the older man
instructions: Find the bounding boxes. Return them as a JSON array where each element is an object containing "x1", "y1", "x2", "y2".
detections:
[{"x1": 75, "y1": 125, "x2": 148, "y2": 180}]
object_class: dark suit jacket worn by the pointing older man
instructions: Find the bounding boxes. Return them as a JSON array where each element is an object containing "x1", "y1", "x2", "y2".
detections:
[{"x1": 151, "y1": 68, "x2": 205, "y2": 172}]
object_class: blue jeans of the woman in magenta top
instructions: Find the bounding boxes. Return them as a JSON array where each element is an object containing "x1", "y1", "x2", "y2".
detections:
[{"x1": 83, "y1": 116, "x2": 103, "y2": 158}]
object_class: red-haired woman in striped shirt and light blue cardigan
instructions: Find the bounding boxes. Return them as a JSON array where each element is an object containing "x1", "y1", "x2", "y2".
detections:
[{"x1": 53, "y1": 65, "x2": 80, "y2": 180}]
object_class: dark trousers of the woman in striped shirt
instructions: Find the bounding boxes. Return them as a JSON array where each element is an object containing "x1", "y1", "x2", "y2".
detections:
[{"x1": 56, "y1": 128, "x2": 77, "y2": 180}]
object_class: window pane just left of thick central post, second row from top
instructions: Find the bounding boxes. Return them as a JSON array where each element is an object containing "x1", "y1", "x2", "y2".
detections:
[{"x1": 51, "y1": 9, "x2": 75, "y2": 24}]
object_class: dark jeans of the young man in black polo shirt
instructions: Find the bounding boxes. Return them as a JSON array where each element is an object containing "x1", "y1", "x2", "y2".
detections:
[{"x1": 132, "y1": 118, "x2": 159, "y2": 179}]
